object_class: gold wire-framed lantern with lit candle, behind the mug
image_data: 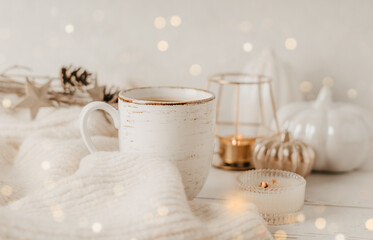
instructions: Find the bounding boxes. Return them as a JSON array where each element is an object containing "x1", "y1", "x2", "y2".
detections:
[{"x1": 207, "y1": 73, "x2": 279, "y2": 170}]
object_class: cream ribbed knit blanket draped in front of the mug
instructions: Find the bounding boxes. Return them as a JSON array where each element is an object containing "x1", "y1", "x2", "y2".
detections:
[{"x1": 0, "y1": 107, "x2": 272, "y2": 240}]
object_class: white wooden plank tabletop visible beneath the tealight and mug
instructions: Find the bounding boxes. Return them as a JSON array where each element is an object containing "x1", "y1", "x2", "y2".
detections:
[{"x1": 197, "y1": 167, "x2": 373, "y2": 240}]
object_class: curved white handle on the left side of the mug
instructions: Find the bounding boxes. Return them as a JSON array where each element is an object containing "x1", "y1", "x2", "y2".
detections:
[{"x1": 79, "y1": 101, "x2": 119, "y2": 153}]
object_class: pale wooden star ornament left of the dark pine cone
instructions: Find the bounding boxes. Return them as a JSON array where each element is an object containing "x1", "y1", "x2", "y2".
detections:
[{"x1": 15, "y1": 79, "x2": 53, "y2": 119}]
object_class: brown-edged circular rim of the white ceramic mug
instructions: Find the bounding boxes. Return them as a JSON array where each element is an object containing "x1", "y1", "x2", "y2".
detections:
[{"x1": 118, "y1": 86, "x2": 215, "y2": 105}]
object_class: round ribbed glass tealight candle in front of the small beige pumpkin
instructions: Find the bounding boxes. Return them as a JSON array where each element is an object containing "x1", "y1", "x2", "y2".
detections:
[{"x1": 237, "y1": 169, "x2": 306, "y2": 225}]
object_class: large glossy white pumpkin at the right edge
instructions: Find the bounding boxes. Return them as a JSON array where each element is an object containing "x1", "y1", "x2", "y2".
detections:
[{"x1": 277, "y1": 87, "x2": 373, "y2": 172}]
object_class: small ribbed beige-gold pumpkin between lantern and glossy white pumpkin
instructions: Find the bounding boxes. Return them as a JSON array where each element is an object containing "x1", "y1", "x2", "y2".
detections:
[{"x1": 253, "y1": 131, "x2": 315, "y2": 176}]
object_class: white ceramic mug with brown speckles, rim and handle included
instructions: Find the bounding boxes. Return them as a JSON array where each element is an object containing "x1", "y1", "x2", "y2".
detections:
[{"x1": 80, "y1": 87, "x2": 215, "y2": 199}]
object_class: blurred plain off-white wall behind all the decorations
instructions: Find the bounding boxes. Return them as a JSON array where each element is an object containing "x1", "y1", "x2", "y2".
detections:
[{"x1": 0, "y1": 0, "x2": 373, "y2": 110}]
